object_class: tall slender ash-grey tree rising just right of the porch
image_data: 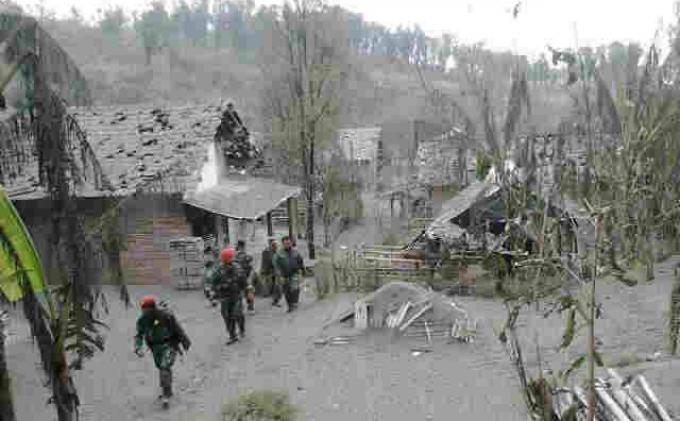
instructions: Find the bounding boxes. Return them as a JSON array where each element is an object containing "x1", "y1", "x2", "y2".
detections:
[{"x1": 261, "y1": 0, "x2": 348, "y2": 259}]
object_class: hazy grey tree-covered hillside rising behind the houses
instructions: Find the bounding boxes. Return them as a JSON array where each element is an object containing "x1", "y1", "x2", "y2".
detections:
[{"x1": 38, "y1": 15, "x2": 571, "y2": 148}]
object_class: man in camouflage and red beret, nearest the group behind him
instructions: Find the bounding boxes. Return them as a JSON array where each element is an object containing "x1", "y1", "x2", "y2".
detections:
[{"x1": 208, "y1": 247, "x2": 251, "y2": 345}]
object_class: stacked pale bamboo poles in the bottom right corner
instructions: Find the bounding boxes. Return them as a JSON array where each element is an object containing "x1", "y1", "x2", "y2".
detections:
[{"x1": 552, "y1": 369, "x2": 674, "y2": 421}]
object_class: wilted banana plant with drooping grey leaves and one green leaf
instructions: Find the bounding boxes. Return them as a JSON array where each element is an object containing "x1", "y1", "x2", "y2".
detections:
[{"x1": 0, "y1": 13, "x2": 105, "y2": 421}]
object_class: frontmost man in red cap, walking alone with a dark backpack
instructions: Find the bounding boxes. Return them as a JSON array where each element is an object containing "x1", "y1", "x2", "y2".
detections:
[{"x1": 135, "y1": 295, "x2": 191, "y2": 407}]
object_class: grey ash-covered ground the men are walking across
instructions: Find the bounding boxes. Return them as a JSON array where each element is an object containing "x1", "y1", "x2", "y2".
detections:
[{"x1": 8, "y1": 258, "x2": 680, "y2": 421}]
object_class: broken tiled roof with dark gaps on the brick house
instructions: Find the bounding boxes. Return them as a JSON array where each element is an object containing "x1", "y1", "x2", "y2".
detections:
[{"x1": 7, "y1": 103, "x2": 222, "y2": 200}]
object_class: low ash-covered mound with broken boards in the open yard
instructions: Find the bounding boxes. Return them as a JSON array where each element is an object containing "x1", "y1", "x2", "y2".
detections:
[{"x1": 354, "y1": 282, "x2": 477, "y2": 342}]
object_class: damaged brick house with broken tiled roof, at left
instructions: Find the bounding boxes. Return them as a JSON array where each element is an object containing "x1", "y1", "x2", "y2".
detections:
[{"x1": 2, "y1": 103, "x2": 295, "y2": 284}]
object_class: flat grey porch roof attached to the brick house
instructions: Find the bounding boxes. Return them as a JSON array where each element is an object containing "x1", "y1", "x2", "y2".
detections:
[{"x1": 184, "y1": 177, "x2": 302, "y2": 220}]
